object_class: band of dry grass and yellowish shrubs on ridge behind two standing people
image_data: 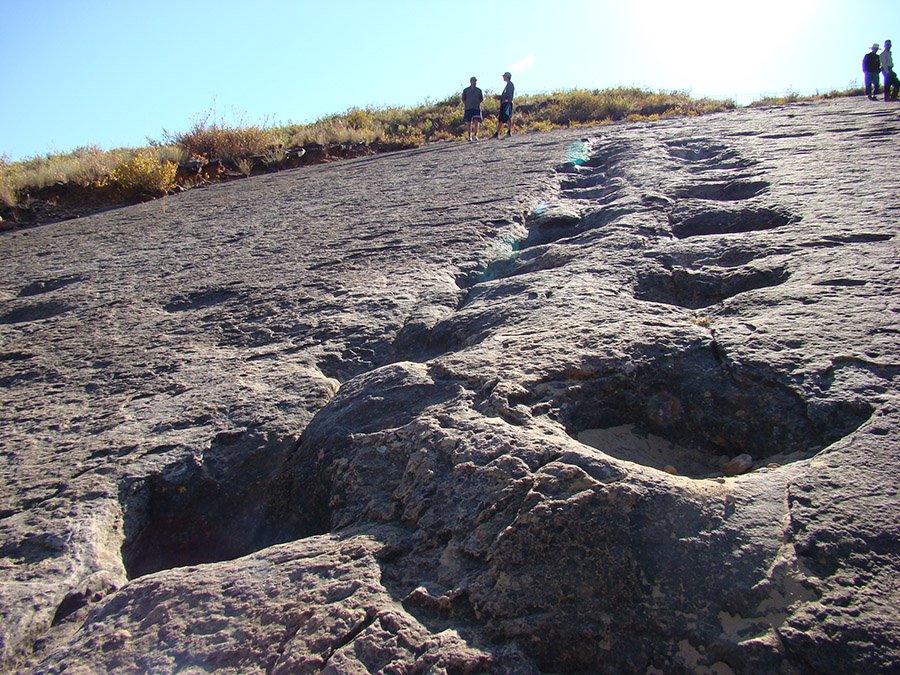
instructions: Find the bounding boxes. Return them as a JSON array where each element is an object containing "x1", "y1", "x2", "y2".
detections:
[{"x1": 0, "y1": 87, "x2": 864, "y2": 224}]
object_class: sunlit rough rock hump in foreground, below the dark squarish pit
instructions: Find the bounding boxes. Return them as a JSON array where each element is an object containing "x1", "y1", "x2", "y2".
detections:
[{"x1": 40, "y1": 528, "x2": 528, "y2": 673}]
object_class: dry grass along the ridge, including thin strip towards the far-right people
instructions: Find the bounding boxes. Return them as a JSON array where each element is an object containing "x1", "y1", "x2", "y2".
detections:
[{"x1": 7, "y1": 87, "x2": 861, "y2": 217}]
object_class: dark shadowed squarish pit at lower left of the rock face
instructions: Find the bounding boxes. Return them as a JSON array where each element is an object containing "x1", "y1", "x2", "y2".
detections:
[{"x1": 120, "y1": 431, "x2": 328, "y2": 578}]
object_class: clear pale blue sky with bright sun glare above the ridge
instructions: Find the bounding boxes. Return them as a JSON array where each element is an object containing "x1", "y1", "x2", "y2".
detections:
[{"x1": 0, "y1": 0, "x2": 900, "y2": 160}]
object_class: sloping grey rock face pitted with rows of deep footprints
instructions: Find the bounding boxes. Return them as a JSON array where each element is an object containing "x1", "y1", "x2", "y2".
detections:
[{"x1": 0, "y1": 100, "x2": 900, "y2": 673}]
